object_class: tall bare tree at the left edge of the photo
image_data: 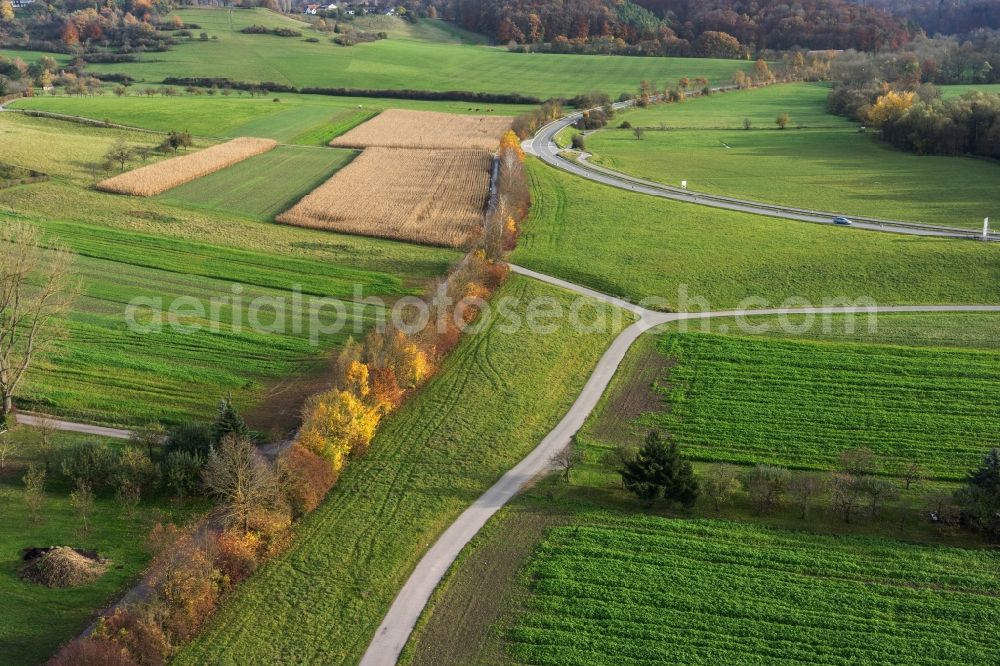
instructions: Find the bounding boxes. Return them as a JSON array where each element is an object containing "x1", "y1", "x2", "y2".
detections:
[{"x1": 0, "y1": 223, "x2": 76, "y2": 422}]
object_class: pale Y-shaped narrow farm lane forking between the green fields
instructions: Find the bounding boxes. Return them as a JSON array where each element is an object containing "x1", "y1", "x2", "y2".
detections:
[{"x1": 361, "y1": 265, "x2": 1000, "y2": 666}]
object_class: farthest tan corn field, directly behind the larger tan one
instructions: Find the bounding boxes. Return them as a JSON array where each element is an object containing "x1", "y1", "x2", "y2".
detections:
[{"x1": 330, "y1": 109, "x2": 513, "y2": 150}]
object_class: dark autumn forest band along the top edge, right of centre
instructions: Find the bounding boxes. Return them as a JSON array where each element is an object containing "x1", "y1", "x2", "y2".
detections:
[{"x1": 425, "y1": 0, "x2": 911, "y2": 53}]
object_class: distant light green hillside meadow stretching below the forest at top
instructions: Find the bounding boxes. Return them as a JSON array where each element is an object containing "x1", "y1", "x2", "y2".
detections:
[{"x1": 11, "y1": 9, "x2": 748, "y2": 99}]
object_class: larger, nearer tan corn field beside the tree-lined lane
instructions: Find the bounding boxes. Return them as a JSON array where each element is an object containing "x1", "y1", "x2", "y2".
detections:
[{"x1": 277, "y1": 148, "x2": 491, "y2": 247}]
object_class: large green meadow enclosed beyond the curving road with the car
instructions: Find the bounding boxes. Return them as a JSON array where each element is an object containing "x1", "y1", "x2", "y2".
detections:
[{"x1": 587, "y1": 126, "x2": 1000, "y2": 229}]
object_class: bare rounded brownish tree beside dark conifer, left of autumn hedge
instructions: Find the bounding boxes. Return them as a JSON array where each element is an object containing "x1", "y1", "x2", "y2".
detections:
[{"x1": 202, "y1": 435, "x2": 278, "y2": 531}]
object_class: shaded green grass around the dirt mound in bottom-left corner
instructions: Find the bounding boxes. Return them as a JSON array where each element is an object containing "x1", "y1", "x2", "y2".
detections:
[{"x1": 0, "y1": 429, "x2": 204, "y2": 664}]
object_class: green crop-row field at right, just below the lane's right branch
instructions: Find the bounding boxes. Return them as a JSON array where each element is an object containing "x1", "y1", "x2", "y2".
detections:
[{"x1": 647, "y1": 333, "x2": 1000, "y2": 479}]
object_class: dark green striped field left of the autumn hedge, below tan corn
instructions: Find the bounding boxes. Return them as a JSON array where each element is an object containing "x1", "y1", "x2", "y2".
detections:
[{"x1": 9, "y1": 221, "x2": 405, "y2": 424}]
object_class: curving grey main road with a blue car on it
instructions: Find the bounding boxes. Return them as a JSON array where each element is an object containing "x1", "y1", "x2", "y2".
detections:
[{"x1": 522, "y1": 102, "x2": 1000, "y2": 241}]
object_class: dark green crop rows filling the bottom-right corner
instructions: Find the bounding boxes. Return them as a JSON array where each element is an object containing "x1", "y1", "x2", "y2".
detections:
[{"x1": 509, "y1": 517, "x2": 1000, "y2": 666}]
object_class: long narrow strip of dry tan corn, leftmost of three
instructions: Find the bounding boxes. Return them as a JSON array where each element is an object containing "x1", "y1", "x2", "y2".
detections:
[{"x1": 97, "y1": 137, "x2": 278, "y2": 197}]
